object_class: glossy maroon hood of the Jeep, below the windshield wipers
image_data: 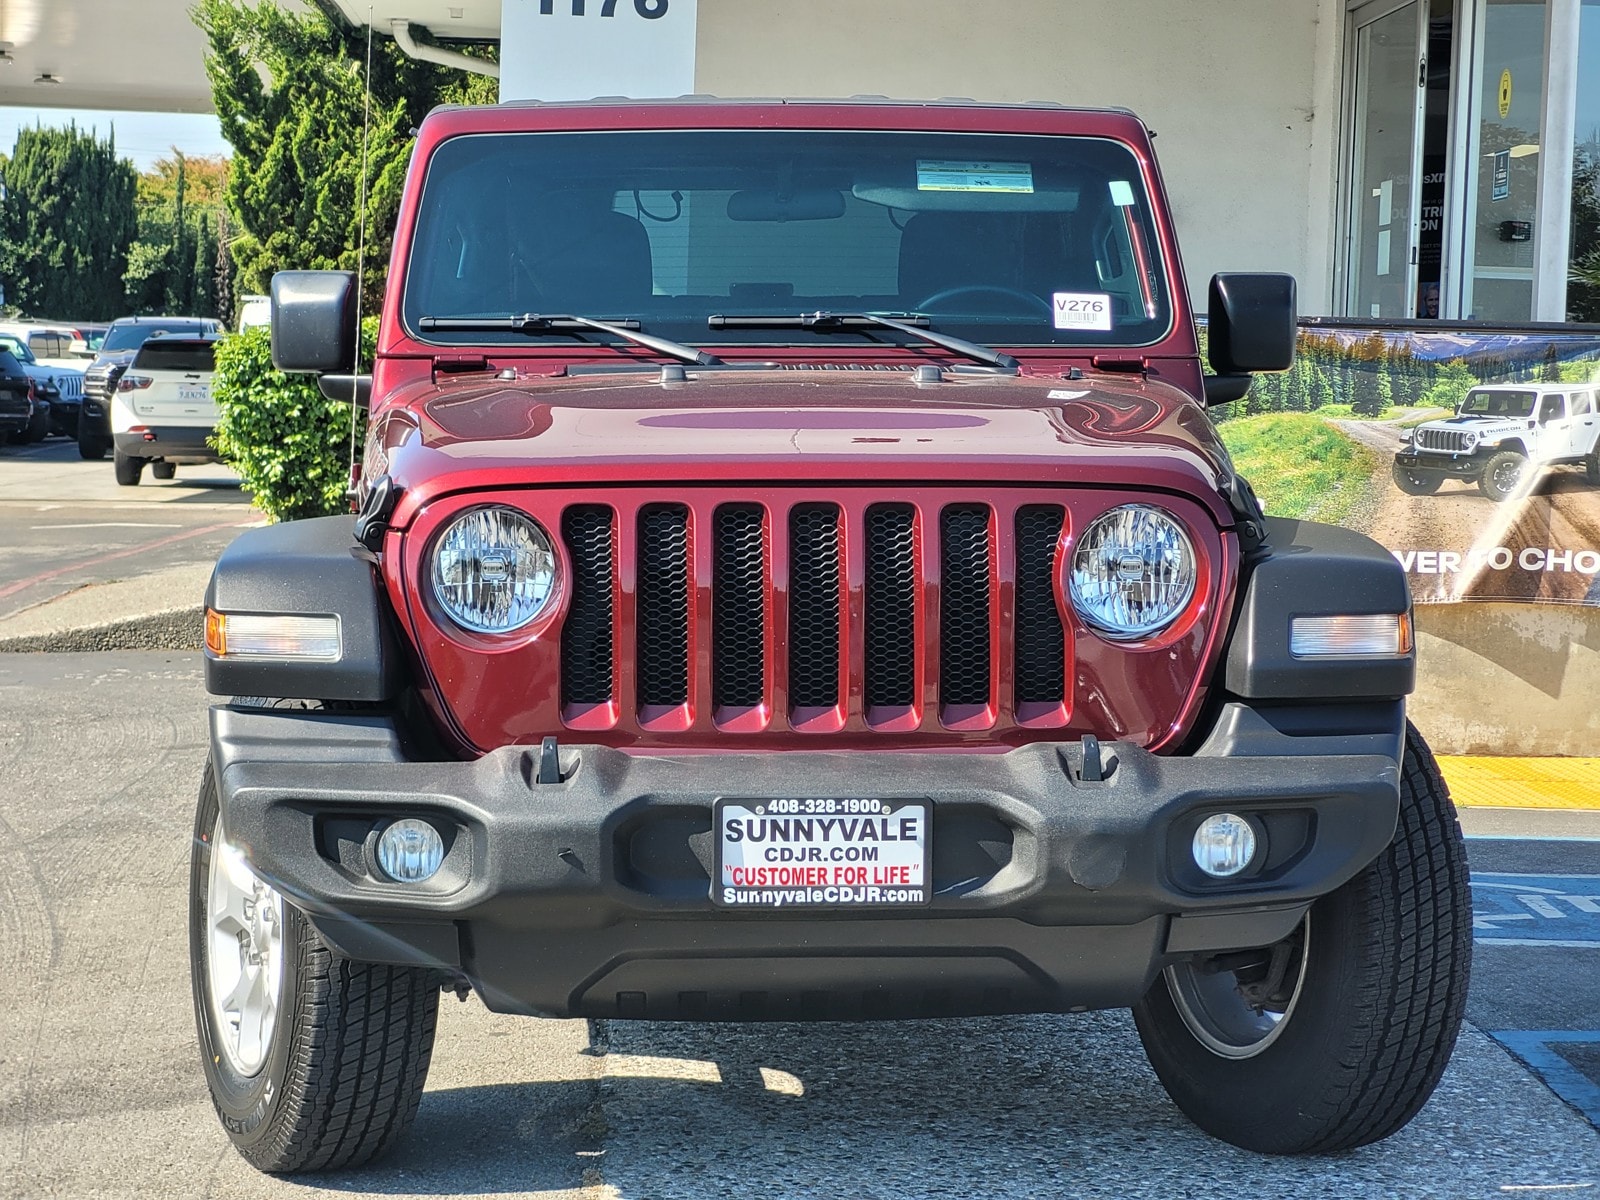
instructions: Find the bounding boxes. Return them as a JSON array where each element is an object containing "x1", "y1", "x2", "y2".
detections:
[{"x1": 377, "y1": 368, "x2": 1232, "y2": 526}]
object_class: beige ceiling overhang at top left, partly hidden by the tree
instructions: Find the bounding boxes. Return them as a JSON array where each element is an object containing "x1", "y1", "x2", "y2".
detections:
[{"x1": 0, "y1": 0, "x2": 501, "y2": 112}]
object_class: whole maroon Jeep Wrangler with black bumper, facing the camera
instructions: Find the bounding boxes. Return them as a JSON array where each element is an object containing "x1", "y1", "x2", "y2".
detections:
[{"x1": 190, "y1": 101, "x2": 1469, "y2": 1171}]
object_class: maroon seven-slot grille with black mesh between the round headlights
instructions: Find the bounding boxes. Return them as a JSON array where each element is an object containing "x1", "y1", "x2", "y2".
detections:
[{"x1": 562, "y1": 498, "x2": 1067, "y2": 733}]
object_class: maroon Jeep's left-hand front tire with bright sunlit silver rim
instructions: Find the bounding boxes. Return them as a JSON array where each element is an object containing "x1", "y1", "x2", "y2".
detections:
[{"x1": 189, "y1": 762, "x2": 438, "y2": 1173}]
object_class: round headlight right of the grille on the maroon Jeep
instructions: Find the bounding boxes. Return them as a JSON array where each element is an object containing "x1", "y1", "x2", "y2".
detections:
[{"x1": 1067, "y1": 504, "x2": 1195, "y2": 642}]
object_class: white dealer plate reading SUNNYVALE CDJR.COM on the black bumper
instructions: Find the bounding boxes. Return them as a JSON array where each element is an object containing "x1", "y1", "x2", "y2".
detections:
[{"x1": 712, "y1": 797, "x2": 933, "y2": 909}]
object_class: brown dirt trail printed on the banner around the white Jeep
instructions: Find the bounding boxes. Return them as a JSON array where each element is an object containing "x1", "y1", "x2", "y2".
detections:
[{"x1": 1331, "y1": 421, "x2": 1600, "y2": 603}]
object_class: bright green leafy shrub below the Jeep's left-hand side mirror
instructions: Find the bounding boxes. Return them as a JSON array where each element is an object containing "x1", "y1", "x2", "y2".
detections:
[{"x1": 211, "y1": 322, "x2": 378, "y2": 522}]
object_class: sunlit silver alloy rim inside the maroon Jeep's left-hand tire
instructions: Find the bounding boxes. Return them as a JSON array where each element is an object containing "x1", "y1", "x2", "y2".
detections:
[{"x1": 206, "y1": 818, "x2": 283, "y2": 1077}]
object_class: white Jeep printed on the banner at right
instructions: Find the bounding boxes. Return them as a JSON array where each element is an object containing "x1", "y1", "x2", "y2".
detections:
[{"x1": 1394, "y1": 384, "x2": 1600, "y2": 502}]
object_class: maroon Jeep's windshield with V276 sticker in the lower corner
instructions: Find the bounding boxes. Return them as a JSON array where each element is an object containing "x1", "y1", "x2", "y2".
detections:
[{"x1": 403, "y1": 130, "x2": 1171, "y2": 356}]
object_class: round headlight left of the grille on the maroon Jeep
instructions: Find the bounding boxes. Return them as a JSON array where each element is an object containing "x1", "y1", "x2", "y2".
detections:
[{"x1": 434, "y1": 509, "x2": 557, "y2": 634}]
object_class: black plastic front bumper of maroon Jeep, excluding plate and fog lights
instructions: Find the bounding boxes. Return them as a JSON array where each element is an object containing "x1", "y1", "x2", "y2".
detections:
[{"x1": 211, "y1": 702, "x2": 1403, "y2": 1019}]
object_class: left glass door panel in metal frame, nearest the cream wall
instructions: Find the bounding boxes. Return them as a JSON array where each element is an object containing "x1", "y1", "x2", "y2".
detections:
[{"x1": 1344, "y1": 0, "x2": 1427, "y2": 318}]
